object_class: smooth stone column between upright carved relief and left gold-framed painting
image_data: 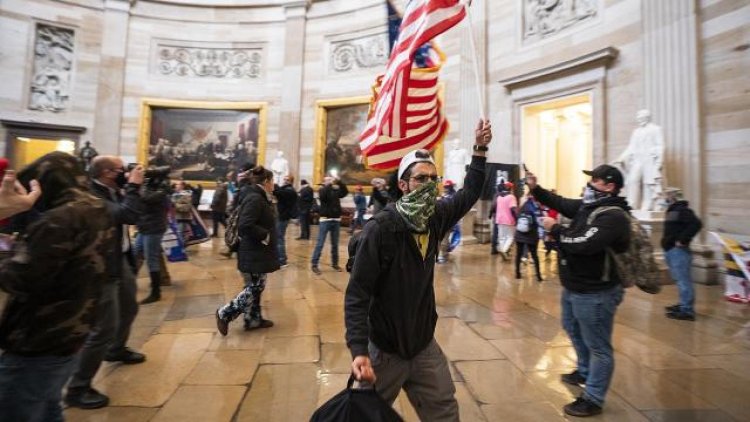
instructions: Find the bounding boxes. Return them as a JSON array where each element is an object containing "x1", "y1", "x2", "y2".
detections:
[{"x1": 91, "y1": 0, "x2": 131, "y2": 155}]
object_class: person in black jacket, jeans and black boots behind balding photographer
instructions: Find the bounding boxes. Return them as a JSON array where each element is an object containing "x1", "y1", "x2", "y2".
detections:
[{"x1": 135, "y1": 167, "x2": 170, "y2": 305}]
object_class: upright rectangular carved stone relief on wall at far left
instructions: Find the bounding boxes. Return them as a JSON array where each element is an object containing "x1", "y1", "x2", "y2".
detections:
[{"x1": 29, "y1": 23, "x2": 75, "y2": 113}]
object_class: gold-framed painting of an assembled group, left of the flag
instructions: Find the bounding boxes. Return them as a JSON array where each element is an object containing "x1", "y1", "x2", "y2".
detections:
[{"x1": 138, "y1": 98, "x2": 266, "y2": 186}]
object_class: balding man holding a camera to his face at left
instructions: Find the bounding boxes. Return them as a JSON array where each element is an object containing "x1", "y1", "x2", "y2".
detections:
[{"x1": 65, "y1": 155, "x2": 146, "y2": 409}]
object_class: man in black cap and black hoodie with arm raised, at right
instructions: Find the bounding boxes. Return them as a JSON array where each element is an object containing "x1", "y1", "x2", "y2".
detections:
[{"x1": 526, "y1": 164, "x2": 630, "y2": 417}]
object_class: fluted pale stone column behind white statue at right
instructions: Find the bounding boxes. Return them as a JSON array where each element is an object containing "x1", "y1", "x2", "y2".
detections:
[{"x1": 641, "y1": 0, "x2": 705, "y2": 215}]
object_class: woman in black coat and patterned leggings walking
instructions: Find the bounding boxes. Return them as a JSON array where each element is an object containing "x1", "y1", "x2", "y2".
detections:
[{"x1": 216, "y1": 166, "x2": 280, "y2": 336}]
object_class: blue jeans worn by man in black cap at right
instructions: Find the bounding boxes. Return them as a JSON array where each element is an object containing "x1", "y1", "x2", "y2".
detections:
[{"x1": 561, "y1": 285, "x2": 625, "y2": 407}]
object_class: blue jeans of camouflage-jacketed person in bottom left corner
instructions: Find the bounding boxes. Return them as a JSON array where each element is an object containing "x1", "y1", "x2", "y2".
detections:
[{"x1": 0, "y1": 353, "x2": 76, "y2": 422}]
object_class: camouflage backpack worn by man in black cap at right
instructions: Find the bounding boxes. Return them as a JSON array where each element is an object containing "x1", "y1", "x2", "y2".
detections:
[{"x1": 587, "y1": 207, "x2": 661, "y2": 294}]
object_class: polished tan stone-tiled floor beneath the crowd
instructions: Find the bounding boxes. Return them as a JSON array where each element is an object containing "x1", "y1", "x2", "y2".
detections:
[{"x1": 55, "y1": 228, "x2": 750, "y2": 422}]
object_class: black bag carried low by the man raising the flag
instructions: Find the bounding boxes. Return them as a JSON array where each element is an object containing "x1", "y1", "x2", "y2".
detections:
[{"x1": 310, "y1": 376, "x2": 403, "y2": 422}]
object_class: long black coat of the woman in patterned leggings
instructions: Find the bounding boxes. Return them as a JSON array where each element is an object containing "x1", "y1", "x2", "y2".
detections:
[{"x1": 237, "y1": 185, "x2": 280, "y2": 274}]
